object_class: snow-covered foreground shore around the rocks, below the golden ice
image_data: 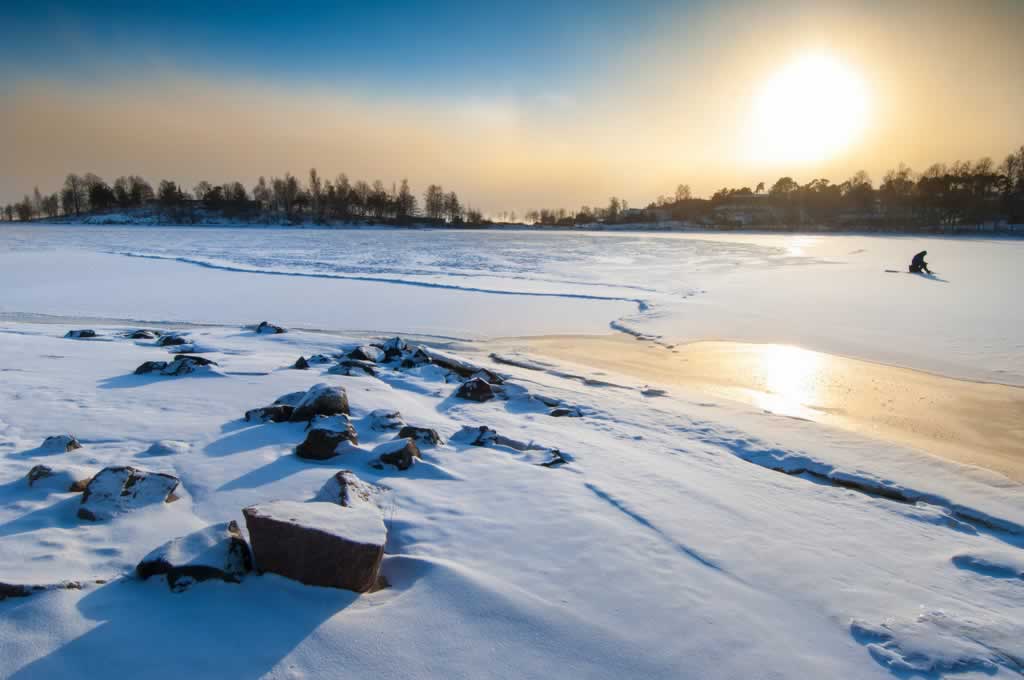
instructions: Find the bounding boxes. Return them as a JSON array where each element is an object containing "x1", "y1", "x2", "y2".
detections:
[{"x1": 0, "y1": 323, "x2": 1024, "y2": 678}]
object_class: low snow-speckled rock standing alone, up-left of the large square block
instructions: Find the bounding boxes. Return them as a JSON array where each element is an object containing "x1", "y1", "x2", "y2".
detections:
[{"x1": 78, "y1": 466, "x2": 180, "y2": 521}]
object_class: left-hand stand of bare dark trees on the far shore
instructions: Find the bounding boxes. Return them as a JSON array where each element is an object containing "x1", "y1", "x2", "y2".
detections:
[{"x1": 2, "y1": 168, "x2": 483, "y2": 224}]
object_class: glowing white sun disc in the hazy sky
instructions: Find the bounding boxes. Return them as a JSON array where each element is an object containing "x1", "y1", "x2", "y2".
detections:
[{"x1": 749, "y1": 54, "x2": 867, "y2": 163}]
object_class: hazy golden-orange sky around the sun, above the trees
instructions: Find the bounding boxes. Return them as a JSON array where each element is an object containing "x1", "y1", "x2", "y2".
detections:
[{"x1": 0, "y1": 2, "x2": 1024, "y2": 214}]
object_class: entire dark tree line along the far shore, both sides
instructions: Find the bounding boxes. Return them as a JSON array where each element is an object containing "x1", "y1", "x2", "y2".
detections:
[{"x1": 8, "y1": 146, "x2": 1024, "y2": 227}]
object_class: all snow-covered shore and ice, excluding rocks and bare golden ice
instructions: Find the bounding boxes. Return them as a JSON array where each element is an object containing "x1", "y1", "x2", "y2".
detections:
[{"x1": 0, "y1": 227, "x2": 1024, "y2": 679}]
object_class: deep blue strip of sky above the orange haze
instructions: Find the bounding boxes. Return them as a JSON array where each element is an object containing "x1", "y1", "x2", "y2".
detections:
[{"x1": 0, "y1": 0, "x2": 693, "y2": 91}]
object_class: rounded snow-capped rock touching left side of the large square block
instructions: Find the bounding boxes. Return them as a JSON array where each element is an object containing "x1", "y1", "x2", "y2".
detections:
[{"x1": 135, "y1": 521, "x2": 253, "y2": 593}]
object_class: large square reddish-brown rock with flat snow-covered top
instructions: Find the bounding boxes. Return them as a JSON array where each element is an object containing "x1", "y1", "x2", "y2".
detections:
[{"x1": 242, "y1": 501, "x2": 387, "y2": 593}]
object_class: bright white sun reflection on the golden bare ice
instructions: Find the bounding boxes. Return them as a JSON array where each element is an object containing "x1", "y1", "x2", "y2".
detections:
[{"x1": 758, "y1": 345, "x2": 821, "y2": 419}]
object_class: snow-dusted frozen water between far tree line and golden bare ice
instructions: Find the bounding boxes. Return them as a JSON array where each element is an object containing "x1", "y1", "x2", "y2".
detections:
[{"x1": 0, "y1": 225, "x2": 1024, "y2": 378}]
